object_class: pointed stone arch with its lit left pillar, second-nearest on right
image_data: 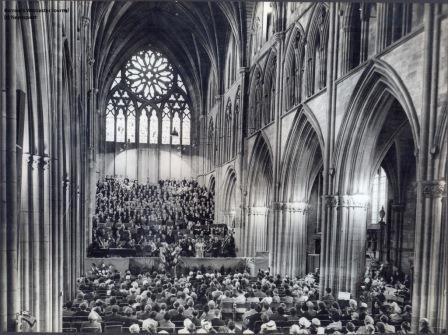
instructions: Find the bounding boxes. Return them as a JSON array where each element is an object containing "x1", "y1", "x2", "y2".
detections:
[{"x1": 271, "y1": 108, "x2": 323, "y2": 276}]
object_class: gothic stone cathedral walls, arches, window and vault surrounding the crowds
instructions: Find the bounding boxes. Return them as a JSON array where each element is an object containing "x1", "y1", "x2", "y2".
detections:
[{"x1": 0, "y1": 1, "x2": 448, "y2": 331}]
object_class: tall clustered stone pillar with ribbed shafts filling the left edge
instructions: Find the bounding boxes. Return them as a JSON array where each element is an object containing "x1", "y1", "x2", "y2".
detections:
[{"x1": 0, "y1": 1, "x2": 94, "y2": 332}]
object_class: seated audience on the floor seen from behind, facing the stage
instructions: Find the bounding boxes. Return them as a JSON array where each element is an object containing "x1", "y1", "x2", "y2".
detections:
[{"x1": 64, "y1": 264, "x2": 416, "y2": 335}]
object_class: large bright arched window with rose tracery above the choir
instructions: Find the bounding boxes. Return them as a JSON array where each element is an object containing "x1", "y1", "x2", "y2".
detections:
[{"x1": 105, "y1": 50, "x2": 191, "y2": 145}]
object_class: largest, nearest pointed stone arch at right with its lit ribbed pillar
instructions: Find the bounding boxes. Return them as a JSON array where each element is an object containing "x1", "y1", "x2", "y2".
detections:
[{"x1": 321, "y1": 63, "x2": 418, "y2": 295}]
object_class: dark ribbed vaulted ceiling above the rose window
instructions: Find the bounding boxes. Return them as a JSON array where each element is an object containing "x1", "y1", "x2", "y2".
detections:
[{"x1": 91, "y1": 1, "x2": 244, "y2": 114}]
